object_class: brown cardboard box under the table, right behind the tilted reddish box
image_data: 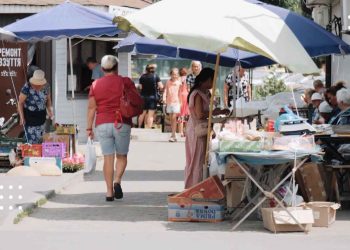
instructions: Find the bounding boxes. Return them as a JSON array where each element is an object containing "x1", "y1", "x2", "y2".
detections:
[{"x1": 225, "y1": 180, "x2": 245, "y2": 208}]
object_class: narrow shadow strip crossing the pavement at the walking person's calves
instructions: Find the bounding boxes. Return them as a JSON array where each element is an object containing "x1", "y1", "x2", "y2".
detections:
[{"x1": 84, "y1": 170, "x2": 184, "y2": 181}]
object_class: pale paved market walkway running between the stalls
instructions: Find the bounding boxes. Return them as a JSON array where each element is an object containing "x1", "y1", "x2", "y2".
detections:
[{"x1": 0, "y1": 131, "x2": 350, "y2": 250}]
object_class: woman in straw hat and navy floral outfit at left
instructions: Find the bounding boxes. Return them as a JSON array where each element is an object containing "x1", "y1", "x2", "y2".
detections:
[{"x1": 18, "y1": 69, "x2": 52, "y2": 144}]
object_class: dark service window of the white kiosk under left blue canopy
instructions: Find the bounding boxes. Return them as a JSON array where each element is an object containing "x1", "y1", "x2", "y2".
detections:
[{"x1": 67, "y1": 39, "x2": 115, "y2": 98}]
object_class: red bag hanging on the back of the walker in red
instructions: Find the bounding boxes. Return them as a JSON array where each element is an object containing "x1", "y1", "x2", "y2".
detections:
[{"x1": 116, "y1": 77, "x2": 144, "y2": 119}]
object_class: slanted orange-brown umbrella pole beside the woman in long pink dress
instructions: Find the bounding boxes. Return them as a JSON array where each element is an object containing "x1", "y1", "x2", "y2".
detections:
[{"x1": 203, "y1": 53, "x2": 220, "y2": 180}]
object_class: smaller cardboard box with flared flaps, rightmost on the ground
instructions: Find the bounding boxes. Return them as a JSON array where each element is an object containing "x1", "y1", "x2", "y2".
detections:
[{"x1": 305, "y1": 202, "x2": 340, "y2": 227}]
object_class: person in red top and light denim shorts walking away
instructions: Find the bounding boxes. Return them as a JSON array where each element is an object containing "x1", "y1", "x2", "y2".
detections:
[{"x1": 87, "y1": 55, "x2": 135, "y2": 201}]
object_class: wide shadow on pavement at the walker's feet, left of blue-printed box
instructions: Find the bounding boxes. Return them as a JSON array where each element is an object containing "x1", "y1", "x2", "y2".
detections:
[{"x1": 30, "y1": 193, "x2": 168, "y2": 222}]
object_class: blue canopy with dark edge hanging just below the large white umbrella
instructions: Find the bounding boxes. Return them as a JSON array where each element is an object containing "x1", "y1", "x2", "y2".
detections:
[{"x1": 115, "y1": 33, "x2": 275, "y2": 68}]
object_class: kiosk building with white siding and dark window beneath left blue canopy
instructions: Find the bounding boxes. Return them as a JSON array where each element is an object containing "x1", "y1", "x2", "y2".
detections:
[{"x1": 0, "y1": 0, "x2": 151, "y2": 141}]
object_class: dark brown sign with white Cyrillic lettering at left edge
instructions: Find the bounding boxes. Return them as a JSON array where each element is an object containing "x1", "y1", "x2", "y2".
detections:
[{"x1": 0, "y1": 41, "x2": 27, "y2": 136}]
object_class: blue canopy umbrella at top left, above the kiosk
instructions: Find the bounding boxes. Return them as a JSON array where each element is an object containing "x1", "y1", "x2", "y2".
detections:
[{"x1": 4, "y1": 1, "x2": 119, "y2": 41}]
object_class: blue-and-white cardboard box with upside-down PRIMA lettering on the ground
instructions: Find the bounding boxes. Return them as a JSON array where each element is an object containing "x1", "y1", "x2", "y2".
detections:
[{"x1": 168, "y1": 195, "x2": 225, "y2": 223}]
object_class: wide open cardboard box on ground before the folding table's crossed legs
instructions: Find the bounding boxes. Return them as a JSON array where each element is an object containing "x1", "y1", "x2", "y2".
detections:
[{"x1": 261, "y1": 207, "x2": 314, "y2": 233}]
